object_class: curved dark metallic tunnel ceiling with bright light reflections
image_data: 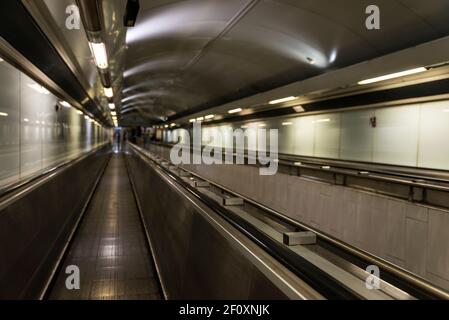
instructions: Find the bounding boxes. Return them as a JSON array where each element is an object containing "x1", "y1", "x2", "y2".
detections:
[{"x1": 122, "y1": 0, "x2": 449, "y2": 124}]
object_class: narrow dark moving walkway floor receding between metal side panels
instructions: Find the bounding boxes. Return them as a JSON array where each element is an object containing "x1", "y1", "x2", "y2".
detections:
[{"x1": 49, "y1": 153, "x2": 161, "y2": 300}]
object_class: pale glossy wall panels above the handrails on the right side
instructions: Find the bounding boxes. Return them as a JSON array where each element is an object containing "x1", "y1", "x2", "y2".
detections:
[{"x1": 163, "y1": 101, "x2": 449, "y2": 170}]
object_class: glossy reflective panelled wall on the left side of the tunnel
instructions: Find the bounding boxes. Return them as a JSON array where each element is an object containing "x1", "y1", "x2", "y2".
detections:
[{"x1": 0, "y1": 57, "x2": 109, "y2": 187}]
